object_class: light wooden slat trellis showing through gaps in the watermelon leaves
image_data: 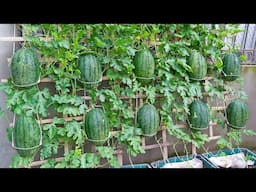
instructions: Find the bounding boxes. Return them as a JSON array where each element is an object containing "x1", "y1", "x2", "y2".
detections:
[{"x1": 0, "y1": 37, "x2": 248, "y2": 167}]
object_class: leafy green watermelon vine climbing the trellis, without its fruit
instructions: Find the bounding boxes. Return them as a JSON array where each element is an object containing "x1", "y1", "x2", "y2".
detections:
[{"x1": 0, "y1": 24, "x2": 254, "y2": 168}]
